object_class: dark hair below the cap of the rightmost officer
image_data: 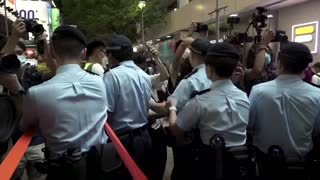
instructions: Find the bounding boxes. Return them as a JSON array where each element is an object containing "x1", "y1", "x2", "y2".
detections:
[{"x1": 279, "y1": 53, "x2": 310, "y2": 74}]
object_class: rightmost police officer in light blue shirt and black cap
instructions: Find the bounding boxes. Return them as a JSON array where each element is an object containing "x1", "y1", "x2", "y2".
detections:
[{"x1": 249, "y1": 42, "x2": 320, "y2": 179}]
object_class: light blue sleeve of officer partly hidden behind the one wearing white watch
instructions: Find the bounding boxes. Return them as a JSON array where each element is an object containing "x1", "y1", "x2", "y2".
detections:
[{"x1": 169, "y1": 79, "x2": 192, "y2": 111}]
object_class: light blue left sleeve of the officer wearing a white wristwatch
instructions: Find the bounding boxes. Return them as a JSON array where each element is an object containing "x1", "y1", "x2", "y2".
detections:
[{"x1": 176, "y1": 98, "x2": 201, "y2": 131}]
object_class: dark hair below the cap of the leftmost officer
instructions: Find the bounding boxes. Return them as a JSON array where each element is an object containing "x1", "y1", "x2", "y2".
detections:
[{"x1": 52, "y1": 36, "x2": 85, "y2": 60}]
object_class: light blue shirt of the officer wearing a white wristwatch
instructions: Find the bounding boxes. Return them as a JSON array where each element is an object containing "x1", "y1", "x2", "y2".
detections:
[{"x1": 176, "y1": 80, "x2": 250, "y2": 147}]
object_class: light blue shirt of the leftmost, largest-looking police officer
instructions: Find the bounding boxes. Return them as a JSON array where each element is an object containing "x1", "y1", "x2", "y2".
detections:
[{"x1": 20, "y1": 64, "x2": 107, "y2": 154}]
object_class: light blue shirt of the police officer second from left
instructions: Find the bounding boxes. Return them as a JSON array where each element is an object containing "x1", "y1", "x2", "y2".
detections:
[{"x1": 104, "y1": 61, "x2": 151, "y2": 132}]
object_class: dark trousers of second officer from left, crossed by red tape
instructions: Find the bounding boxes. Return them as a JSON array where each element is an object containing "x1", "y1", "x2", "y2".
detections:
[{"x1": 103, "y1": 126, "x2": 152, "y2": 180}]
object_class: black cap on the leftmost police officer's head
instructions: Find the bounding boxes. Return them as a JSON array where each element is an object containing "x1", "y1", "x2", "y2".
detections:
[{"x1": 52, "y1": 25, "x2": 87, "y2": 46}]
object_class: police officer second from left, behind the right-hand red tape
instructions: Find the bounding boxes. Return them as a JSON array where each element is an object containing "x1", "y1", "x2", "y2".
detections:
[{"x1": 104, "y1": 35, "x2": 151, "y2": 179}]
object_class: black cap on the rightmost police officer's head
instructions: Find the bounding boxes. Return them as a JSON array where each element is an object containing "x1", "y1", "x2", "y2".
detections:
[{"x1": 279, "y1": 42, "x2": 313, "y2": 63}]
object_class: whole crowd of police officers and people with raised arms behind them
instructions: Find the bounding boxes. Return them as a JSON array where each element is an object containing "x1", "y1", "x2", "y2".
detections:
[{"x1": 0, "y1": 19, "x2": 320, "y2": 180}]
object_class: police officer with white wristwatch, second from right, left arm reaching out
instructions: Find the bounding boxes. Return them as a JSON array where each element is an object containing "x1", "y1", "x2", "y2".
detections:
[{"x1": 169, "y1": 43, "x2": 250, "y2": 179}]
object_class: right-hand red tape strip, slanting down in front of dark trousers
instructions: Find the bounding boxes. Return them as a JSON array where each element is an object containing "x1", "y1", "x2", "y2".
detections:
[{"x1": 104, "y1": 123, "x2": 148, "y2": 180}]
